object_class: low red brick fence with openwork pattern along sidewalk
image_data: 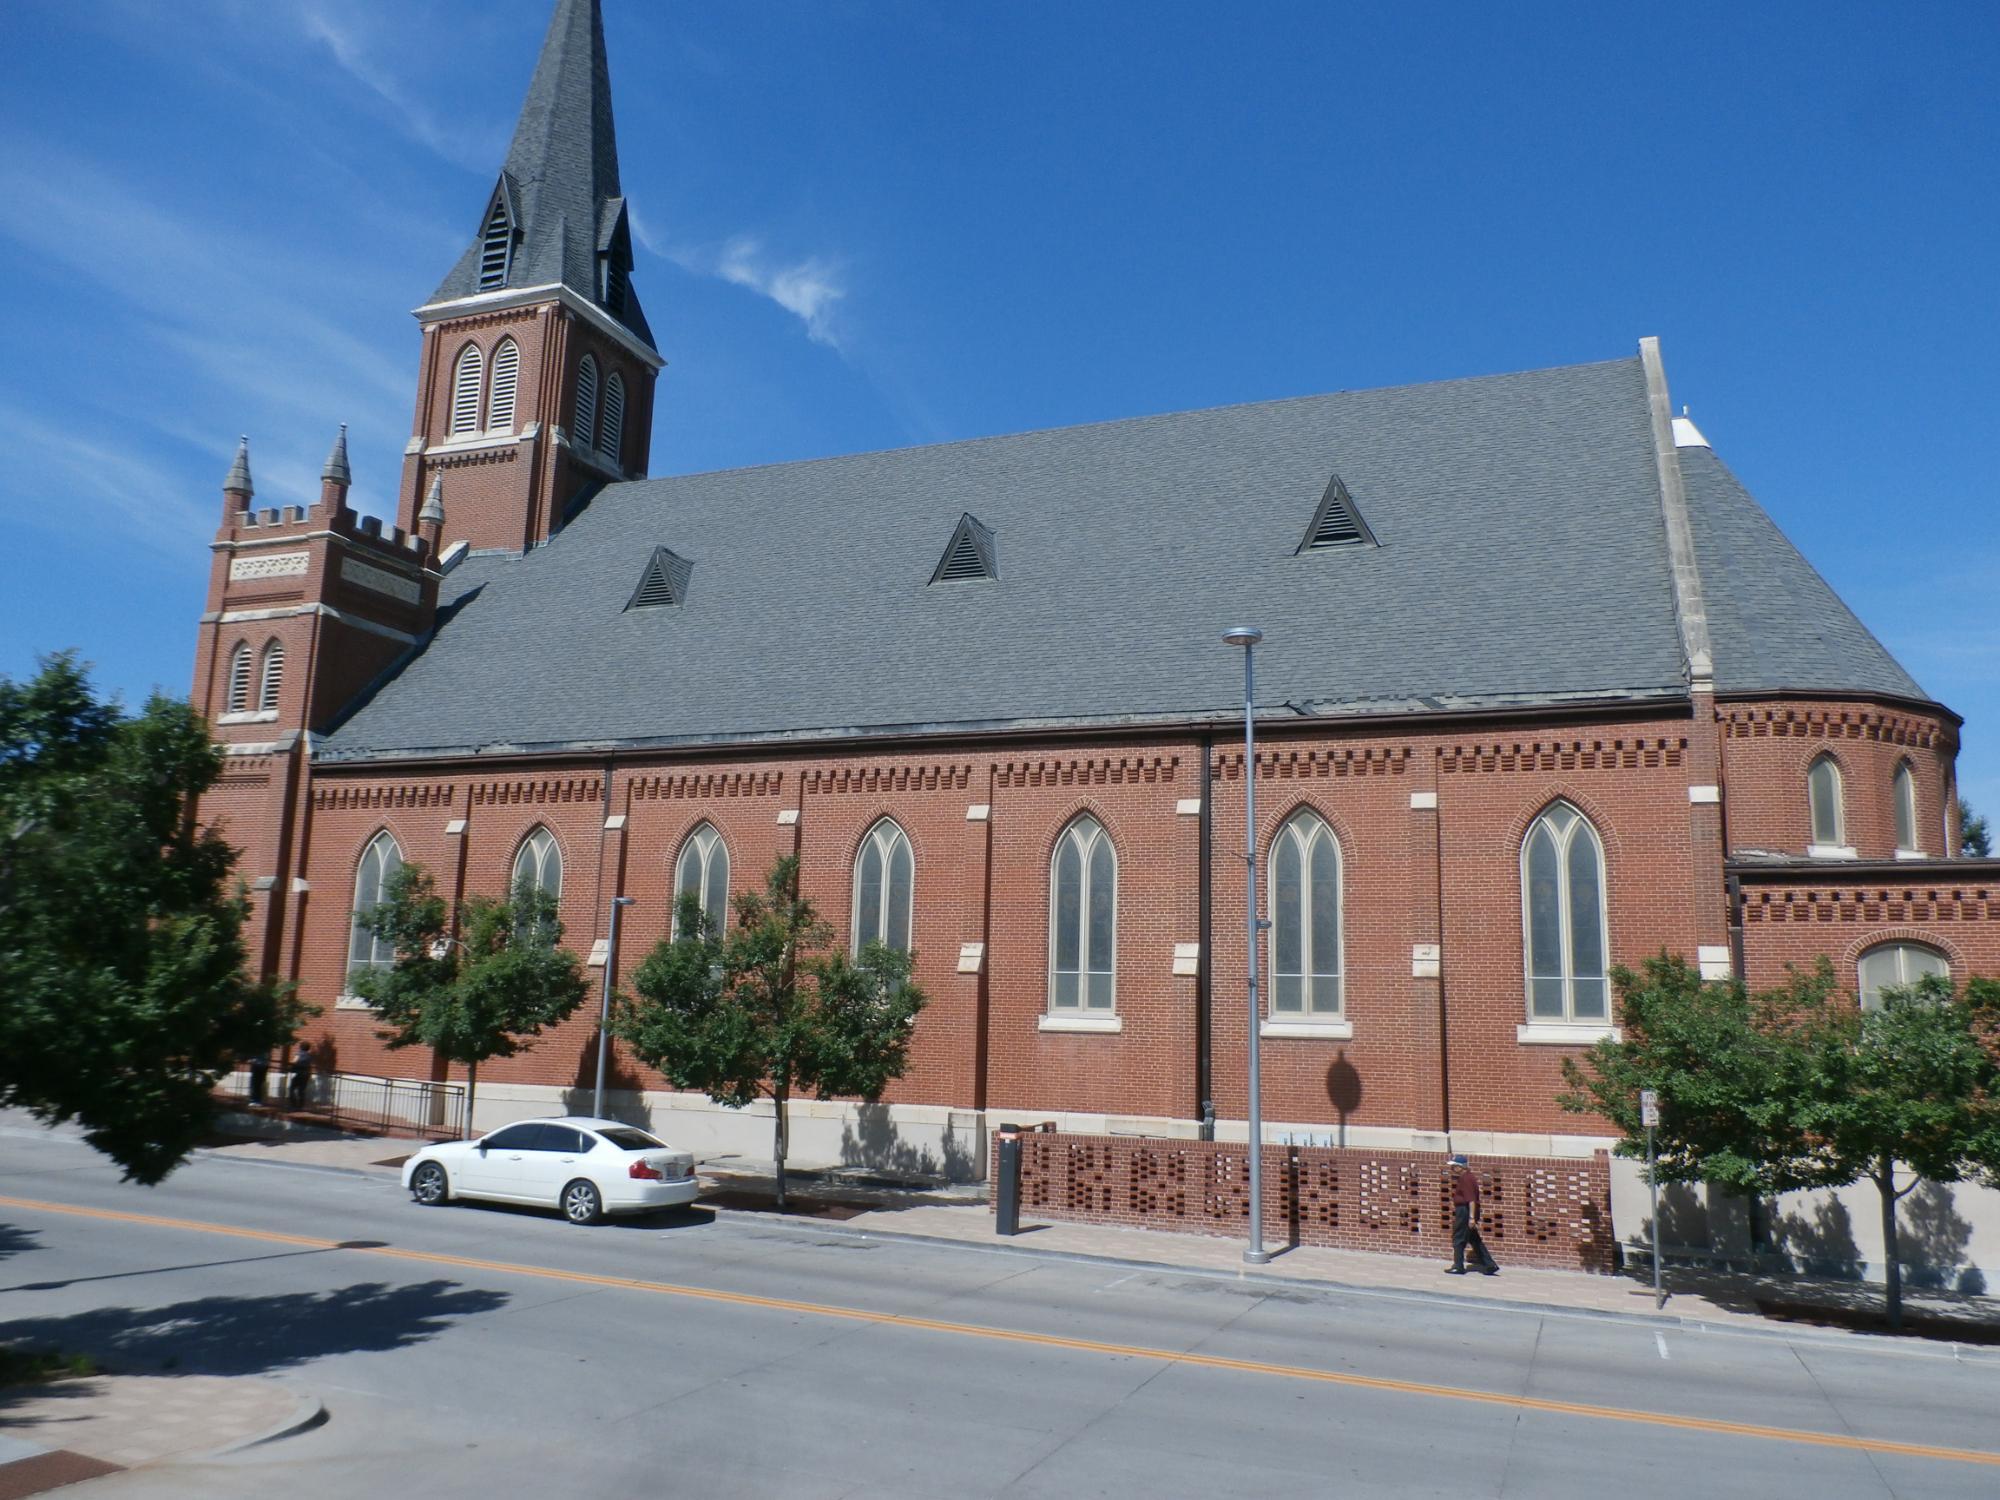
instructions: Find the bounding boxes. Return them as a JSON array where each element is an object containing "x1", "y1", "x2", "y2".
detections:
[{"x1": 988, "y1": 1132, "x2": 1614, "y2": 1272}]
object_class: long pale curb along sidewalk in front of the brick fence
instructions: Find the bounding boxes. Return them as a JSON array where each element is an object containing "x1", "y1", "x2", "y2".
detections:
[{"x1": 712, "y1": 1204, "x2": 2000, "y2": 1366}]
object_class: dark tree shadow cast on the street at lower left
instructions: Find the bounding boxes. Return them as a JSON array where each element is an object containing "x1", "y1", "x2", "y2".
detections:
[{"x1": 0, "y1": 1280, "x2": 508, "y2": 1384}]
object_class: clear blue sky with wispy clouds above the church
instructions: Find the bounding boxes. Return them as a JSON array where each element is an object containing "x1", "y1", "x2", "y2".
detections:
[{"x1": 0, "y1": 0, "x2": 2000, "y2": 828}]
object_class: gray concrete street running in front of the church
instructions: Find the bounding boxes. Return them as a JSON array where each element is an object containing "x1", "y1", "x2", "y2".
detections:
[{"x1": 0, "y1": 1134, "x2": 2000, "y2": 1500}]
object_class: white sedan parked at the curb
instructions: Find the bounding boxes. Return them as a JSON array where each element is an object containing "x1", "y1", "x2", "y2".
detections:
[{"x1": 402, "y1": 1116, "x2": 700, "y2": 1224}]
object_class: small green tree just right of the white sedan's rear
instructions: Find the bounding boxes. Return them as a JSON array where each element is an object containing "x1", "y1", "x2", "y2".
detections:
[{"x1": 612, "y1": 856, "x2": 924, "y2": 1208}]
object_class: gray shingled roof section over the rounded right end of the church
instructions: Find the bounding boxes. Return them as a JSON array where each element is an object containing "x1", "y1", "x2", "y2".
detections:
[{"x1": 1680, "y1": 448, "x2": 1928, "y2": 698}]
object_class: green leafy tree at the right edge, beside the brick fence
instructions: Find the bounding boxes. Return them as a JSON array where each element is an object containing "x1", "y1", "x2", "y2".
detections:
[{"x1": 1558, "y1": 956, "x2": 2000, "y2": 1326}]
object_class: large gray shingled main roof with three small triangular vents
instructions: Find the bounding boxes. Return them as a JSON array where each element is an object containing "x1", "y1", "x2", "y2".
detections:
[{"x1": 320, "y1": 360, "x2": 1728, "y2": 760}]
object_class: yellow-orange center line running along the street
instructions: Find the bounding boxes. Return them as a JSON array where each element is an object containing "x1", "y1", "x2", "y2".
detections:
[{"x1": 0, "y1": 1196, "x2": 2000, "y2": 1468}]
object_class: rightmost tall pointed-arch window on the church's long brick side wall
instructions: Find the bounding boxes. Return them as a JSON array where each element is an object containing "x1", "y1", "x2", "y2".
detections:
[{"x1": 1520, "y1": 802, "x2": 1610, "y2": 1024}]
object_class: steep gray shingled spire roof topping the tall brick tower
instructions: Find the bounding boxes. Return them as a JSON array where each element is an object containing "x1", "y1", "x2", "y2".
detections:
[{"x1": 430, "y1": 0, "x2": 652, "y2": 348}]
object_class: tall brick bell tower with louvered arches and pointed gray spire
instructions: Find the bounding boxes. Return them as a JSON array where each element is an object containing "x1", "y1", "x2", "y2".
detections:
[{"x1": 396, "y1": 0, "x2": 664, "y2": 552}]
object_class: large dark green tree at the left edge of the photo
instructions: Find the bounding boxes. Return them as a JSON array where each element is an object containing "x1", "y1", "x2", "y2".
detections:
[{"x1": 0, "y1": 654, "x2": 278, "y2": 1184}]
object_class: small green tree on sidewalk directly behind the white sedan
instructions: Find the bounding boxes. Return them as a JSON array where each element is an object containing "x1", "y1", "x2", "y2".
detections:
[{"x1": 354, "y1": 864, "x2": 588, "y2": 1128}]
